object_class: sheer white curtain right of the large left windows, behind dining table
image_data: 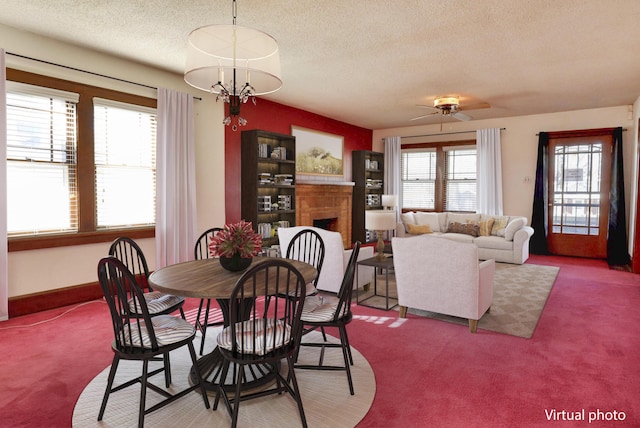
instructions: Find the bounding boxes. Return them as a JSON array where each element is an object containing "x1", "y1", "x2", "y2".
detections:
[{"x1": 156, "y1": 88, "x2": 197, "y2": 269}]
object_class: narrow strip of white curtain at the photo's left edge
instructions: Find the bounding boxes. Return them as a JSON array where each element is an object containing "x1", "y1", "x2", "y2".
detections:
[{"x1": 0, "y1": 49, "x2": 9, "y2": 321}]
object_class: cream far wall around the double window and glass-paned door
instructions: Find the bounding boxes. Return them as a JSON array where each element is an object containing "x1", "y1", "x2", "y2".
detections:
[{"x1": 373, "y1": 106, "x2": 640, "y2": 251}]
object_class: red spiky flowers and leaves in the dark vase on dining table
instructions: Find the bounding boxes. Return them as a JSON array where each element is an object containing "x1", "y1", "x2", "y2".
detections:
[{"x1": 209, "y1": 220, "x2": 262, "y2": 259}]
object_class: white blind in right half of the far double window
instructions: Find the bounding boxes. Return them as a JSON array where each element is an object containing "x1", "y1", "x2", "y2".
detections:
[{"x1": 444, "y1": 146, "x2": 476, "y2": 212}]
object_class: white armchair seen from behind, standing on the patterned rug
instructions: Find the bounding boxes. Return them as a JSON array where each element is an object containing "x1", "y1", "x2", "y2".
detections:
[{"x1": 391, "y1": 235, "x2": 495, "y2": 333}]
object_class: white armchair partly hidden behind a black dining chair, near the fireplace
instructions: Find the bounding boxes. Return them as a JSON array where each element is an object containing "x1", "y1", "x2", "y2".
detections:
[{"x1": 278, "y1": 226, "x2": 374, "y2": 293}]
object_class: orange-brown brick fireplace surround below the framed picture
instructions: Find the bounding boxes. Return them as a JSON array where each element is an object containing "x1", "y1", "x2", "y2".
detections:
[{"x1": 296, "y1": 182, "x2": 354, "y2": 248}]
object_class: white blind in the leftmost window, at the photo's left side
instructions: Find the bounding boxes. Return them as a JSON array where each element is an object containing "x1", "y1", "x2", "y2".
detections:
[{"x1": 7, "y1": 82, "x2": 79, "y2": 236}]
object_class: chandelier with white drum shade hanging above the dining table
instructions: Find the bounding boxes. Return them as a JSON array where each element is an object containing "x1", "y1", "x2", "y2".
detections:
[{"x1": 184, "y1": 0, "x2": 282, "y2": 131}]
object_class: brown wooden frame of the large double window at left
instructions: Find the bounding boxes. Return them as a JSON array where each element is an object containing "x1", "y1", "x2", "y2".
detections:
[{"x1": 6, "y1": 68, "x2": 157, "y2": 252}]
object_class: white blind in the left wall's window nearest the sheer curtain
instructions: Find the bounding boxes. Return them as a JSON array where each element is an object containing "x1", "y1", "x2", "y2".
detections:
[{"x1": 93, "y1": 98, "x2": 156, "y2": 229}]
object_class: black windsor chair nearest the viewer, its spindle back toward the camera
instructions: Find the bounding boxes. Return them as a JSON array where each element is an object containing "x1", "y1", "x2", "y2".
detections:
[{"x1": 213, "y1": 259, "x2": 307, "y2": 427}]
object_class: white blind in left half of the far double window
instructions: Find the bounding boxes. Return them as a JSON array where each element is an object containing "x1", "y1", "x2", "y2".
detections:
[{"x1": 401, "y1": 149, "x2": 436, "y2": 210}]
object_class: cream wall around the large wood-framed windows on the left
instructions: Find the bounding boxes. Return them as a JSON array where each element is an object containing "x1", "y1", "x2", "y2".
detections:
[{"x1": 0, "y1": 25, "x2": 225, "y2": 297}]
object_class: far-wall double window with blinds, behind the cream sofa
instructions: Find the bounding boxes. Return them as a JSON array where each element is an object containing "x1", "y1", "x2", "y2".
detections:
[{"x1": 401, "y1": 142, "x2": 476, "y2": 212}]
